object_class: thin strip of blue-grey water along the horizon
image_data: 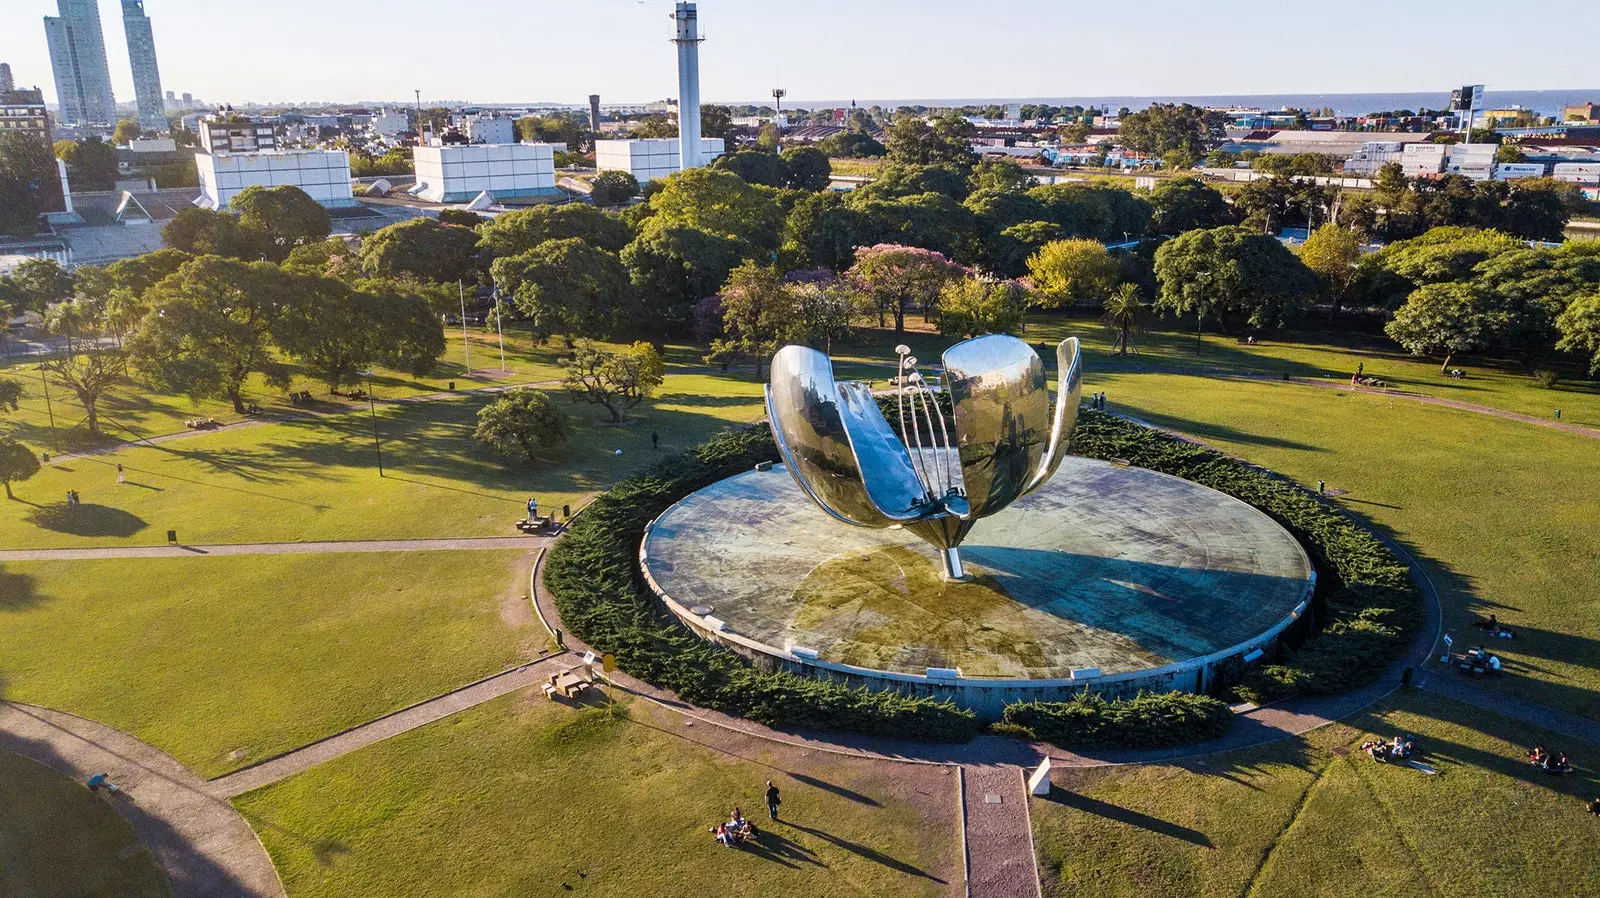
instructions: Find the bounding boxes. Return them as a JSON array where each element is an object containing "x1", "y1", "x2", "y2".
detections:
[{"x1": 739, "y1": 88, "x2": 1600, "y2": 118}]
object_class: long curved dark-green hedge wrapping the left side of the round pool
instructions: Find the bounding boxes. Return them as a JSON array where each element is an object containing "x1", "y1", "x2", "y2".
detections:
[{"x1": 544, "y1": 424, "x2": 978, "y2": 741}]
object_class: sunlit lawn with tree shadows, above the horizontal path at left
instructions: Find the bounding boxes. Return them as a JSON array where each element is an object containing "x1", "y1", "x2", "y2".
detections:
[{"x1": 0, "y1": 373, "x2": 762, "y2": 547}]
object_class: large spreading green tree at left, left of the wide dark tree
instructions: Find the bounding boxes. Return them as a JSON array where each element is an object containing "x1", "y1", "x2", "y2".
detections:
[{"x1": 128, "y1": 254, "x2": 294, "y2": 413}]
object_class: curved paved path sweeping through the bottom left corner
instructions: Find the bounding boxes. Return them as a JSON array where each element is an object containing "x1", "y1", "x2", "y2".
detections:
[{"x1": 0, "y1": 701, "x2": 283, "y2": 898}]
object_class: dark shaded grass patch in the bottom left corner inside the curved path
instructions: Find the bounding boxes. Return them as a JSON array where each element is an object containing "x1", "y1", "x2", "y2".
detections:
[{"x1": 0, "y1": 751, "x2": 171, "y2": 898}]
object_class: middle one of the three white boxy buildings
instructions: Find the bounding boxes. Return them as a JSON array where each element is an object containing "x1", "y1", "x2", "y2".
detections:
[{"x1": 411, "y1": 144, "x2": 560, "y2": 203}]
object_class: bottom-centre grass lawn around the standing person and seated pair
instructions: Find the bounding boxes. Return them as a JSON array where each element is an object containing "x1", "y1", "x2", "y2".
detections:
[{"x1": 234, "y1": 690, "x2": 962, "y2": 898}]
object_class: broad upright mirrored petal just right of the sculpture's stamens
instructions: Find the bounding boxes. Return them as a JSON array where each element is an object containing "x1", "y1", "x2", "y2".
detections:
[{"x1": 944, "y1": 335, "x2": 1050, "y2": 517}]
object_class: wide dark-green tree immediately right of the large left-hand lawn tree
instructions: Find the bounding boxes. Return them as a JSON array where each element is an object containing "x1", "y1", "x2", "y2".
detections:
[{"x1": 272, "y1": 274, "x2": 445, "y2": 392}]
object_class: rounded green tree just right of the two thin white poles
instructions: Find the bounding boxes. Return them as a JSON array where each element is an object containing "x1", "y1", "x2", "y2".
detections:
[{"x1": 491, "y1": 237, "x2": 638, "y2": 336}]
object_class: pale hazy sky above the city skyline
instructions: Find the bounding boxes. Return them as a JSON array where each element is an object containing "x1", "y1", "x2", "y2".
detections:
[{"x1": 0, "y1": 0, "x2": 1600, "y2": 102}]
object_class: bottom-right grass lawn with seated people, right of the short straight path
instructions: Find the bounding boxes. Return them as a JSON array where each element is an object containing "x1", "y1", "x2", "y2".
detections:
[{"x1": 1032, "y1": 692, "x2": 1600, "y2": 898}]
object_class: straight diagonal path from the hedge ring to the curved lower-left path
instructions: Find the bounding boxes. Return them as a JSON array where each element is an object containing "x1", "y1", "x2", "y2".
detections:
[{"x1": 206, "y1": 653, "x2": 573, "y2": 799}]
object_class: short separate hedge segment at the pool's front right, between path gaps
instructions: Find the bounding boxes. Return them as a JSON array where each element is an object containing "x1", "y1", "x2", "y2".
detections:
[{"x1": 995, "y1": 692, "x2": 1234, "y2": 749}]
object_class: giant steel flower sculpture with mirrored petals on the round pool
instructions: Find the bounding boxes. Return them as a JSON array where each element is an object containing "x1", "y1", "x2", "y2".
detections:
[{"x1": 766, "y1": 335, "x2": 1083, "y2": 579}]
